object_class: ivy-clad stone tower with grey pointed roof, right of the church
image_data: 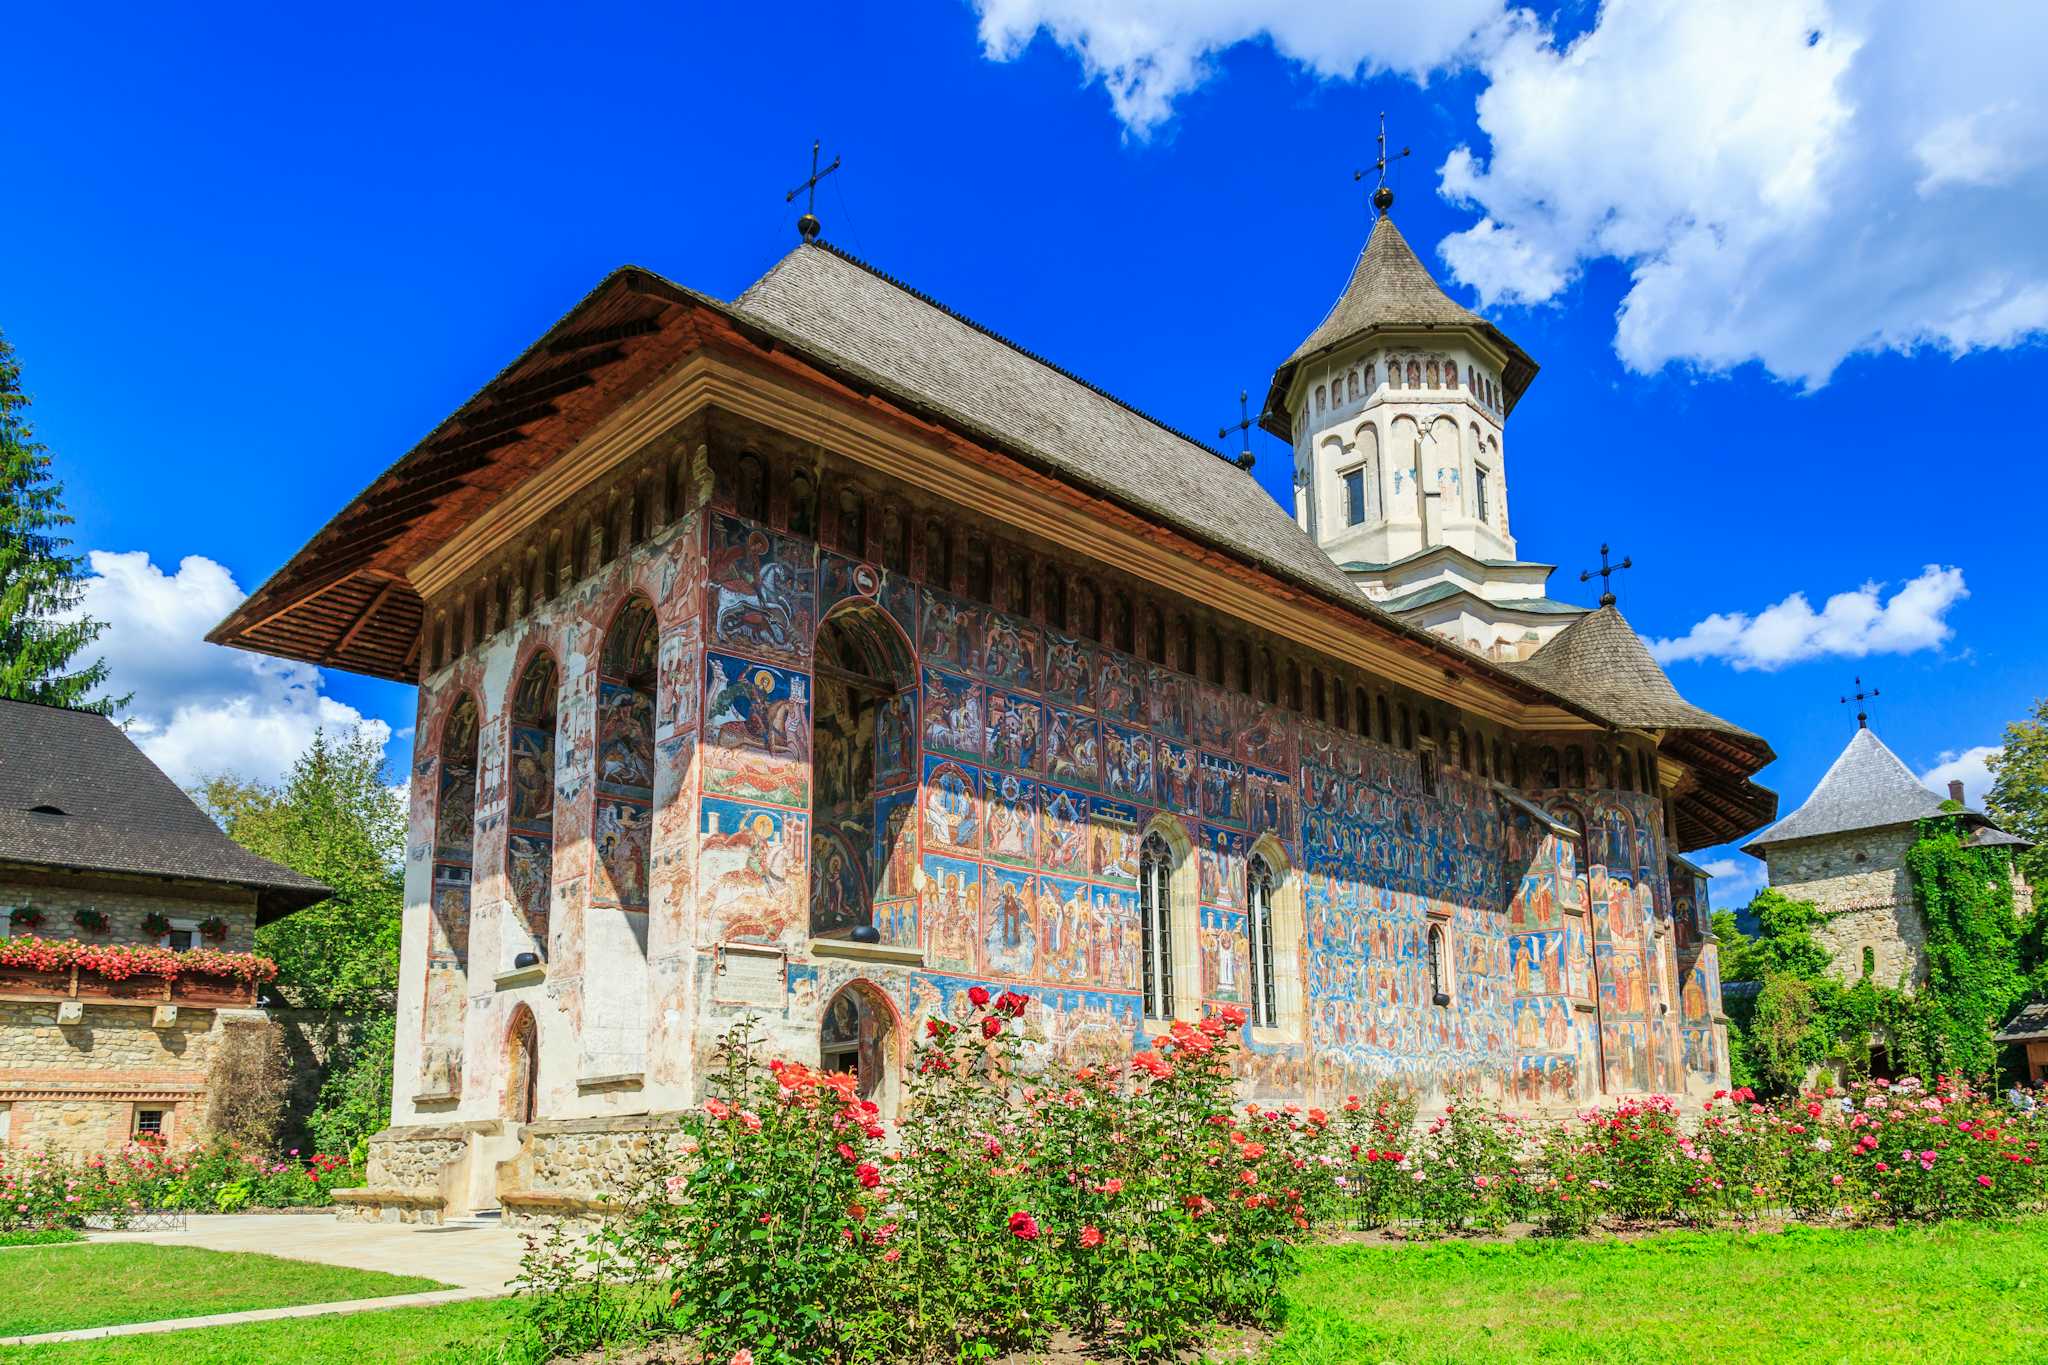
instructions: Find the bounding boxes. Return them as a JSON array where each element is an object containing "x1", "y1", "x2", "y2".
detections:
[{"x1": 1743, "y1": 718, "x2": 2034, "y2": 988}]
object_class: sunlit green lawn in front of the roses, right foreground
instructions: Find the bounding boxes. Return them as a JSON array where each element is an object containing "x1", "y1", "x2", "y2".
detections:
[{"x1": 1268, "y1": 1220, "x2": 2048, "y2": 1365}]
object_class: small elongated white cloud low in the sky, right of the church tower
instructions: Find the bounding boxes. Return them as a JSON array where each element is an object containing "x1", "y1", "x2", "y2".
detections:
[{"x1": 1649, "y1": 565, "x2": 1970, "y2": 671}]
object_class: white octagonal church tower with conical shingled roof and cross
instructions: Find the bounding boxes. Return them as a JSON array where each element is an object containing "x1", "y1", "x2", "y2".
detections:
[{"x1": 1260, "y1": 184, "x2": 1585, "y2": 659}]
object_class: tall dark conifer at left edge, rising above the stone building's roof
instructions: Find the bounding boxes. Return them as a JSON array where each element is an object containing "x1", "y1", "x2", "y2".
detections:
[{"x1": 0, "y1": 336, "x2": 127, "y2": 716}]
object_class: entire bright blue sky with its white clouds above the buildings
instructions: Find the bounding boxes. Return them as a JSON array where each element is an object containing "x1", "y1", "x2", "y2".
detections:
[{"x1": 0, "y1": 0, "x2": 2048, "y2": 900}]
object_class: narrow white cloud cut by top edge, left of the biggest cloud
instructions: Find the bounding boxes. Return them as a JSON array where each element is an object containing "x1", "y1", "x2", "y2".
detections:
[{"x1": 973, "y1": 0, "x2": 1505, "y2": 139}]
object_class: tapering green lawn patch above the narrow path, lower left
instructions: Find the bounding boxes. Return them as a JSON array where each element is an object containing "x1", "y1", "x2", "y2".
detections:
[{"x1": 0, "y1": 1242, "x2": 446, "y2": 1340}]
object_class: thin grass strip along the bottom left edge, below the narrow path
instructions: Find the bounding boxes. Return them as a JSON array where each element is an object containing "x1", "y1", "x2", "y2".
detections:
[{"x1": 0, "y1": 1300, "x2": 514, "y2": 1365}]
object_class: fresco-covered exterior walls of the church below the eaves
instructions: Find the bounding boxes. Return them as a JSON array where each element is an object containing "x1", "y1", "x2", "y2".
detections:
[{"x1": 399, "y1": 485, "x2": 1724, "y2": 1121}]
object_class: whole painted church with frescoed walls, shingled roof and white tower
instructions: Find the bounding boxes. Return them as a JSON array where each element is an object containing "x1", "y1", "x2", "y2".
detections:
[{"x1": 211, "y1": 192, "x2": 1778, "y2": 1222}]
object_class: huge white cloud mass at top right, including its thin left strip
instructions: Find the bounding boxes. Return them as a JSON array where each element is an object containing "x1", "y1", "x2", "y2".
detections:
[{"x1": 975, "y1": 0, "x2": 2048, "y2": 387}]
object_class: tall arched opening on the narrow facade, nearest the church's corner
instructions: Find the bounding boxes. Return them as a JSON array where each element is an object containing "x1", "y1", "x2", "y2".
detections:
[{"x1": 590, "y1": 596, "x2": 659, "y2": 911}]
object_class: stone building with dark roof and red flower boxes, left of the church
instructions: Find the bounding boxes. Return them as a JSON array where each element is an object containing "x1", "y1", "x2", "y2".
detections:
[{"x1": 0, "y1": 700, "x2": 328, "y2": 1152}]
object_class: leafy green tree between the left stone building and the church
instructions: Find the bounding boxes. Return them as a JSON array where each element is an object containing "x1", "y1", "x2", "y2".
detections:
[{"x1": 199, "y1": 731, "x2": 406, "y2": 1015}]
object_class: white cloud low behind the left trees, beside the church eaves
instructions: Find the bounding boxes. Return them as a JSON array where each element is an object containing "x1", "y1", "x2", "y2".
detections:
[{"x1": 80, "y1": 551, "x2": 391, "y2": 786}]
